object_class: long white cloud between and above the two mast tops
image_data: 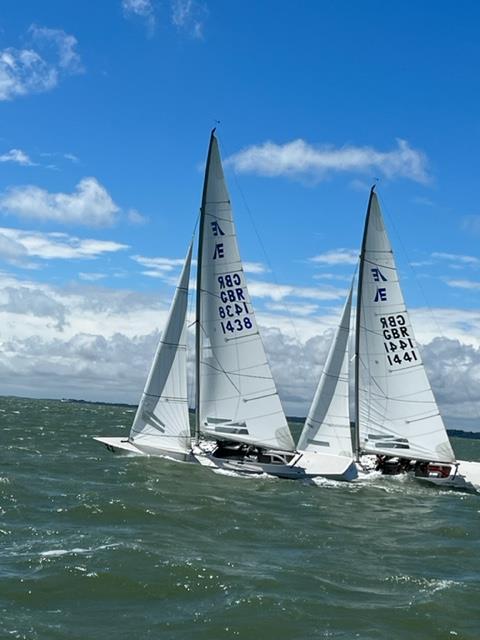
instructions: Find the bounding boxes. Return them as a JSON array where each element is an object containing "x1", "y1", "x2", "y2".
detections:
[{"x1": 227, "y1": 139, "x2": 429, "y2": 183}]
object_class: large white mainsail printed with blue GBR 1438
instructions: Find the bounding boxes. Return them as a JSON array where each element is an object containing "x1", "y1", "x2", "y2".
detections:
[{"x1": 197, "y1": 133, "x2": 294, "y2": 450}]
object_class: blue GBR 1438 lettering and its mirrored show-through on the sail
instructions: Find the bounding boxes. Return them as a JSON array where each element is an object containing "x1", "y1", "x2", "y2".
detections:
[{"x1": 217, "y1": 273, "x2": 253, "y2": 333}]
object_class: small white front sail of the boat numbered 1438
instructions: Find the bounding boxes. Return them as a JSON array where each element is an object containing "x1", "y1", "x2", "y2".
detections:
[{"x1": 130, "y1": 245, "x2": 192, "y2": 452}]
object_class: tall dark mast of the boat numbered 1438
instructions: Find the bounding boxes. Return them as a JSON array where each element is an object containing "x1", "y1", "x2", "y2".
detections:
[{"x1": 195, "y1": 127, "x2": 216, "y2": 444}]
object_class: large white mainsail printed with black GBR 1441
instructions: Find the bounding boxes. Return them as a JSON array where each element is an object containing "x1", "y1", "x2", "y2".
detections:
[{"x1": 356, "y1": 189, "x2": 455, "y2": 462}]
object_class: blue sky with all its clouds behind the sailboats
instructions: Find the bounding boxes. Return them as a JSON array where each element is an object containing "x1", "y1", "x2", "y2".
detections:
[{"x1": 0, "y1": 0, "x2": 480, "y2": 430}]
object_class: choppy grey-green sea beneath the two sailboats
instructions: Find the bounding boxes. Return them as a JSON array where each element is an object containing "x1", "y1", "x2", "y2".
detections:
[{"x1": 0, "y1": 397, "x2": 480, "y2": 640}]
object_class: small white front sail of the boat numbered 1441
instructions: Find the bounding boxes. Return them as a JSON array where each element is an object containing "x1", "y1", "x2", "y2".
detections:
[{"x1": 297, "y1": 285, "x2": 353, "y2": 457}]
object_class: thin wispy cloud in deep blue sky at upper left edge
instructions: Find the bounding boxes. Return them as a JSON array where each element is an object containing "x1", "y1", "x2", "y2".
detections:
[{"x1": 0, "y1": 25, "x2": 83, "y2": 100}]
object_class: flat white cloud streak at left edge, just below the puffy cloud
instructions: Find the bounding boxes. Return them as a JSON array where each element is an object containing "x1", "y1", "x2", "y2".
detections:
[{"x1": 0, "y1": 227, "x2": 128, "y2": 263}]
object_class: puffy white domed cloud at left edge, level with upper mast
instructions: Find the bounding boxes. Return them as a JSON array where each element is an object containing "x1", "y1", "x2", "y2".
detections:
[{"x1": 0, "y1": 178, "x2": 119, "y2": 226}]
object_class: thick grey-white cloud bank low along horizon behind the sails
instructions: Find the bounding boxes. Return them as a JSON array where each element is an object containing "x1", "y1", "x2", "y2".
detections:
[{"x1": 0, "y1": 273, "x2": 480, "y2": 426}]
